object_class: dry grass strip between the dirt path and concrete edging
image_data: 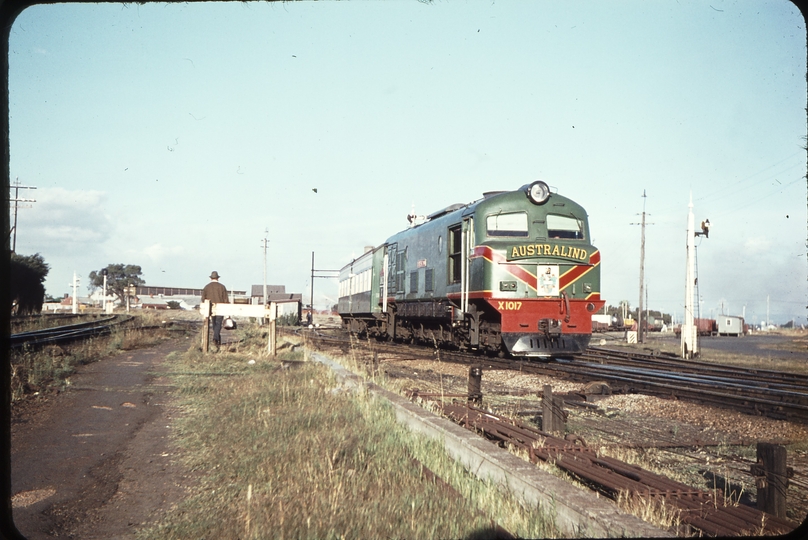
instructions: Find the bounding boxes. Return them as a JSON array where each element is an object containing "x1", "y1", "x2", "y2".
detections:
[{"x1": 138, "y1": 328, "x2": 559, "y2": 539}]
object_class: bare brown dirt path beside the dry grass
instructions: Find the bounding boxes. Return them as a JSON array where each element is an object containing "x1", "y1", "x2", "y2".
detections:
[{"x1": 11, "y1": 339, "x2": 189, "y2": 539}]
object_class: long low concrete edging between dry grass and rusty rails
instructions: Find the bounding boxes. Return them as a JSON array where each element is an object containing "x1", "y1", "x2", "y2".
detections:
[{"x1": 311, "y1": 353, "x2": 675, "y2": 538}]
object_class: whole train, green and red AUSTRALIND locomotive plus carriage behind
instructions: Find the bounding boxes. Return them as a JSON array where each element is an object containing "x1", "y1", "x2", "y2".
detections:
[{"x1": 339, "y1": 181, "x2": 604, "y2": 357}]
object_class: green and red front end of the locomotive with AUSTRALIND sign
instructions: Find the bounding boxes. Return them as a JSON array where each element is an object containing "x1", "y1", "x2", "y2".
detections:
[{"x1": 468, "y1": 181, "x2": 605, "y2": 357}]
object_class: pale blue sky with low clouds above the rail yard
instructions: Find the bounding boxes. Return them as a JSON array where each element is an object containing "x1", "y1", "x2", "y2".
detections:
[{"x1": 9, "y1": 0, "x2": 808, "y2": 323}]
